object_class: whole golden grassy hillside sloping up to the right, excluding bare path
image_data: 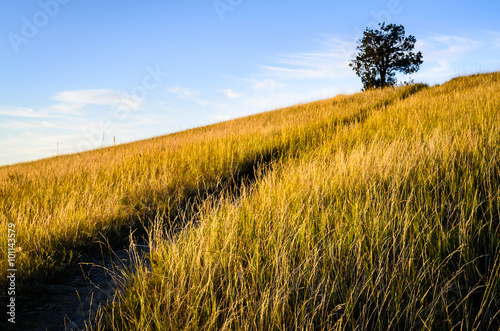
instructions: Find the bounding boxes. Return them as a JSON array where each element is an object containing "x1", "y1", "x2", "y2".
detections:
[{"x1": 0, "y1": 73, "x2": 500, "y2": 330}]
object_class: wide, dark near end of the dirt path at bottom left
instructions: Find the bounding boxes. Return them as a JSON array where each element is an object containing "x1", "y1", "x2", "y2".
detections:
[{"x1": 17, "y1": 245, "x2": 149, "y2": 331}]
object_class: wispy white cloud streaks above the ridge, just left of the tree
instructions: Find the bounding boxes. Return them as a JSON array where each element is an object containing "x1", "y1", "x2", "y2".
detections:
[{"x1": 217, "y1": 37, "x2": 359, "y2": 115}]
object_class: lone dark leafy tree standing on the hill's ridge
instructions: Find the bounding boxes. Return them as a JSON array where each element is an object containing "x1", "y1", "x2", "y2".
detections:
[{"x1": 349, "y1": 22, "x2": 423, "y2": 90}]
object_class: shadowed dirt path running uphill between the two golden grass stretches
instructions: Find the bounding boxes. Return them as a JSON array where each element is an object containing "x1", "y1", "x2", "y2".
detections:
[{"x1": 9, "y1": 170, "x2": 260, "y2": 331}]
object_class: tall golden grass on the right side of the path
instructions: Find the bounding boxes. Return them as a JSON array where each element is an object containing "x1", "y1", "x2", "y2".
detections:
[{"x1": 100, "y1": 74, "x2": 500, "y2": 330}]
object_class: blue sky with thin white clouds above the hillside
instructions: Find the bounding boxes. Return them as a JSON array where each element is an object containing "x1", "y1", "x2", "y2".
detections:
[{"x1": 0, "y1": 0, "x2": 500, "y2": 165}]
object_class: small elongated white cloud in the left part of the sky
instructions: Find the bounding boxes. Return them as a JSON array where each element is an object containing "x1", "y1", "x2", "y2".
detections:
[{"x1": 52, "y1": 89, "x2": 142, "y2": 110}]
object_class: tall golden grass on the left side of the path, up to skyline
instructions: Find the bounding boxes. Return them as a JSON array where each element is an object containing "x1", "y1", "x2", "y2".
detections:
[{"x1": 0, "y1": 82, "x2": 418, "y2": 284}]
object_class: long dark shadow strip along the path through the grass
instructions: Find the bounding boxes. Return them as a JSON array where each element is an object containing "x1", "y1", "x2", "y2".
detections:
[{"x1": 2, "y1": 85, "x2": 432, "y2": 330}]
